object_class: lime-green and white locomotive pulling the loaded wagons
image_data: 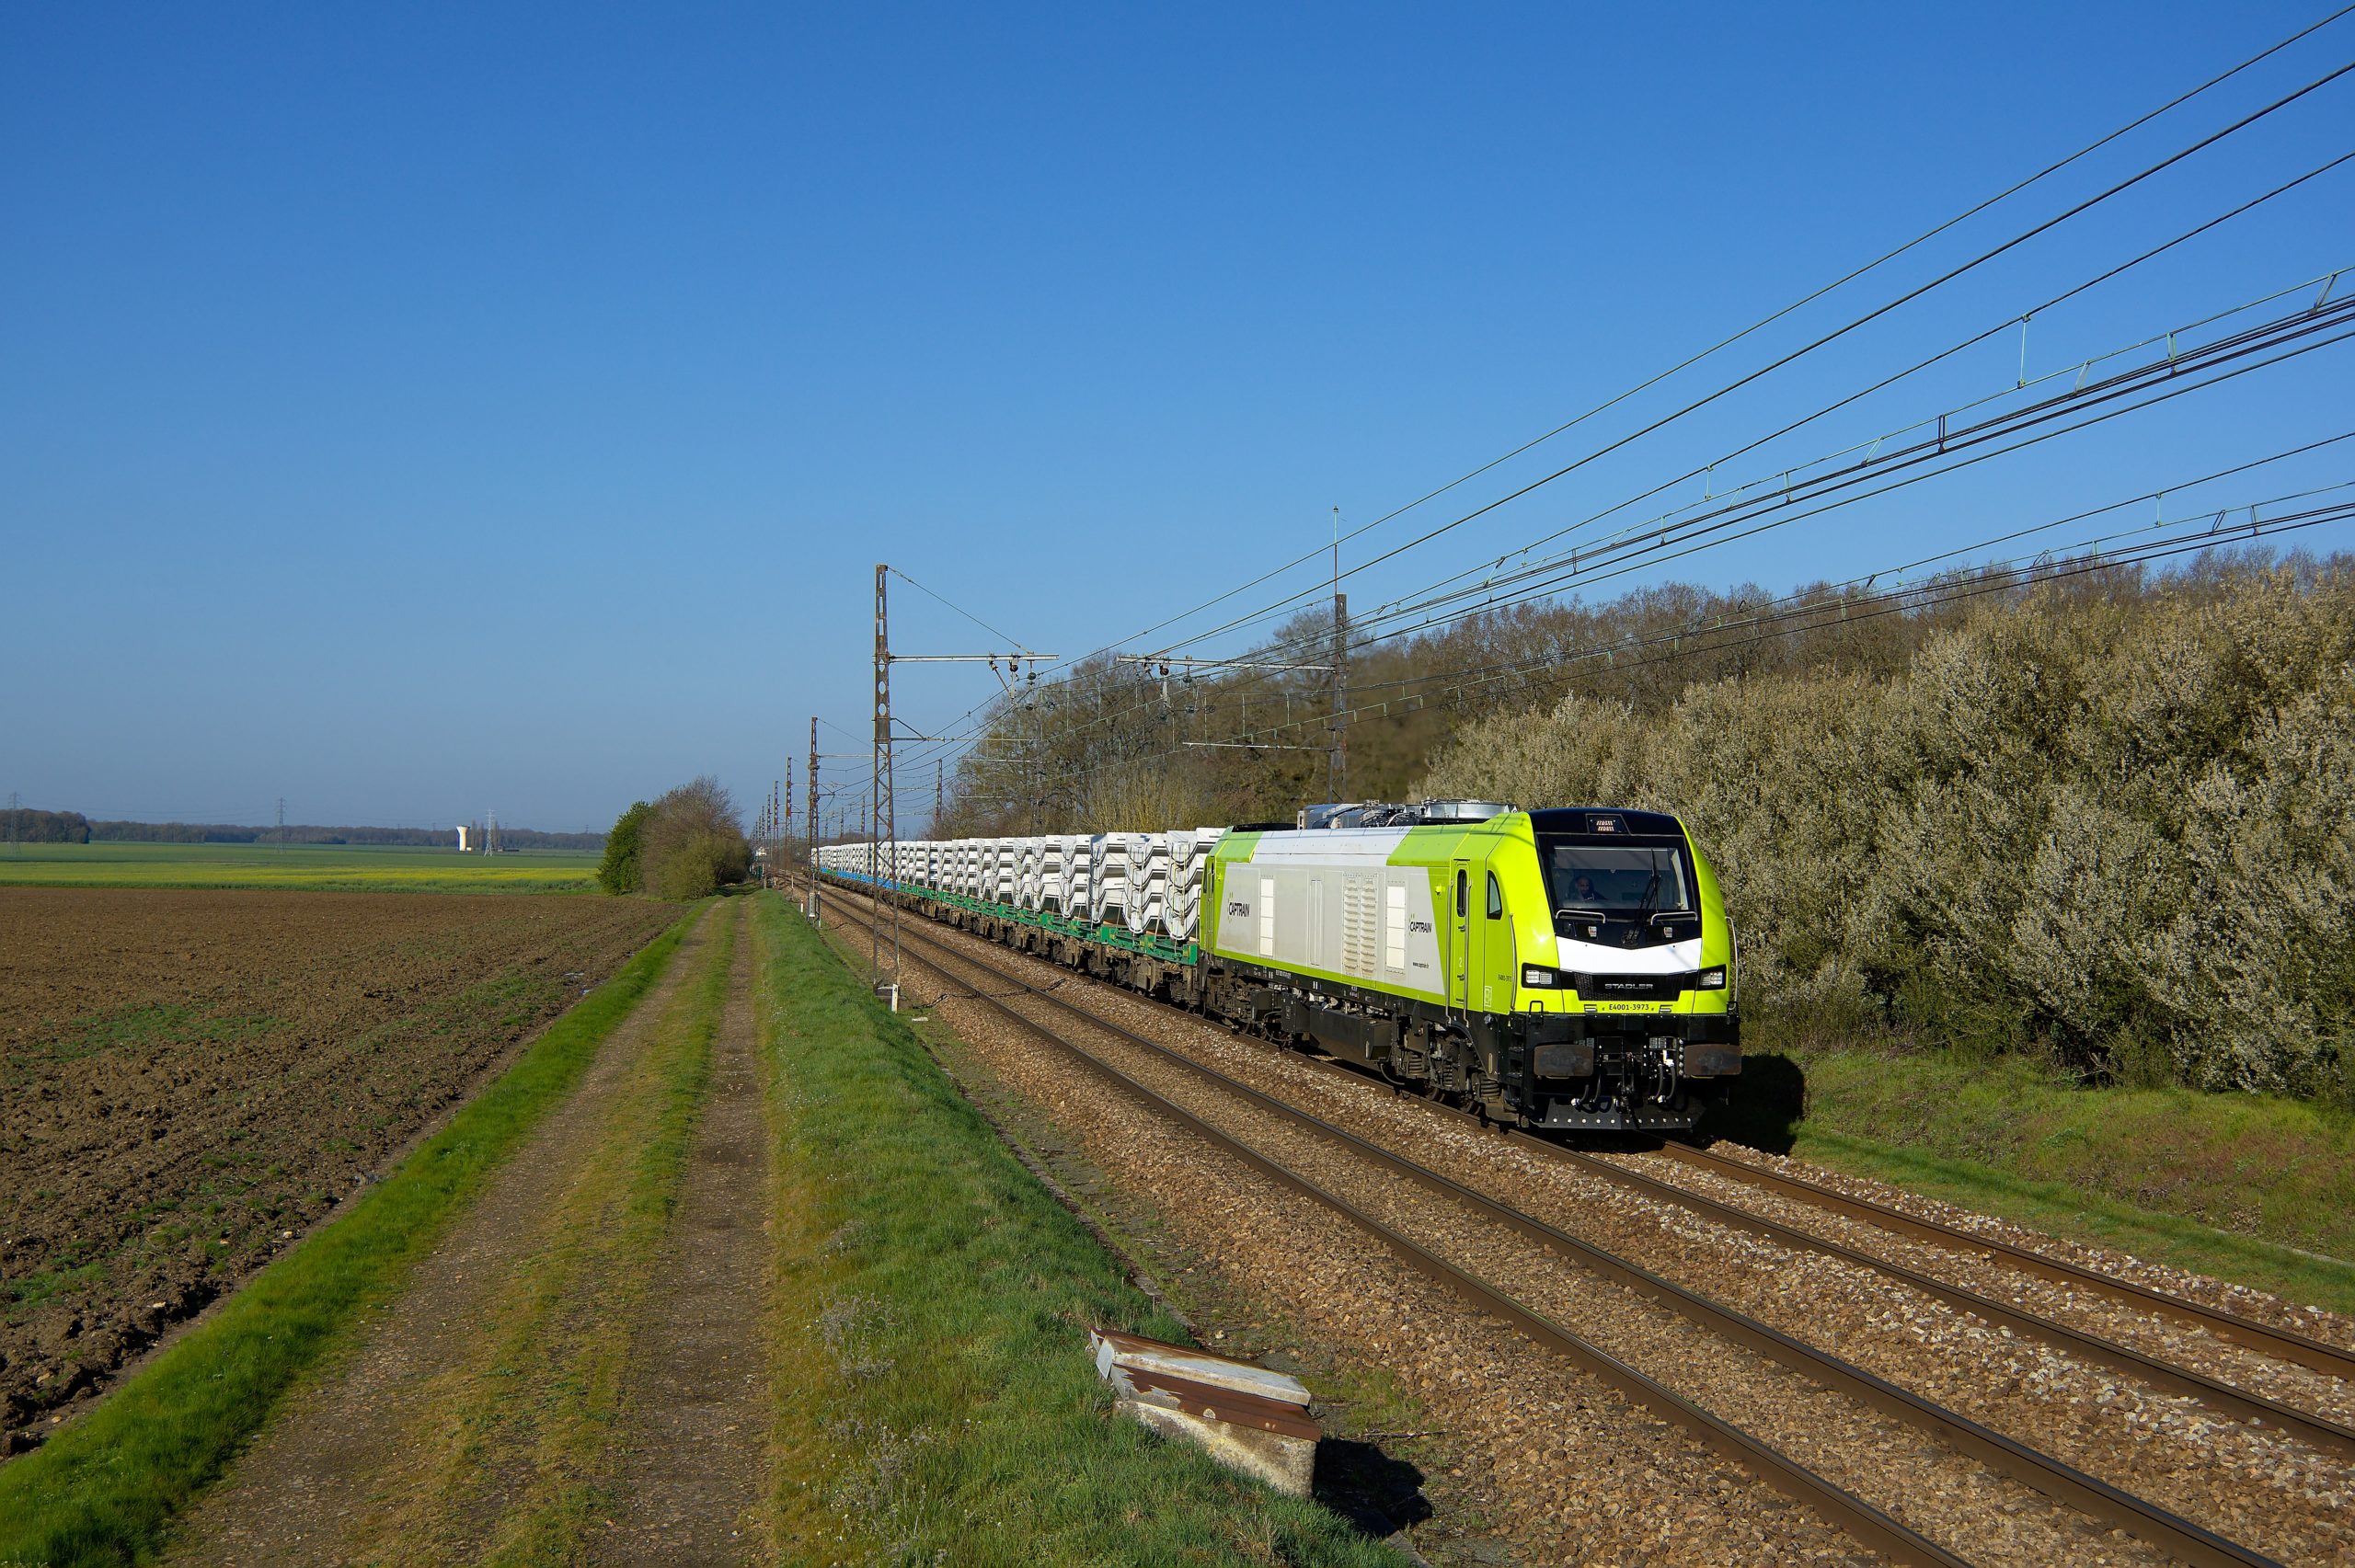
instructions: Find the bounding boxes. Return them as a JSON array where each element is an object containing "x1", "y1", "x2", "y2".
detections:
[{"x1": 1203, "y1": 803, "x2": 1742, "y2": 1130}]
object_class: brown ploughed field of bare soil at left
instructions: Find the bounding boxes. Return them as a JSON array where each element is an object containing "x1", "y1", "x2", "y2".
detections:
[{"x1": 0, "y1": 887, "x2": 676, "y2": 1453}]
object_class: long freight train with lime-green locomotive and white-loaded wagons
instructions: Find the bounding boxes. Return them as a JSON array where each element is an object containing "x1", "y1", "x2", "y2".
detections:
[{"x1": 815, "y1": 800, "x2": 1742, "y2": 1130}]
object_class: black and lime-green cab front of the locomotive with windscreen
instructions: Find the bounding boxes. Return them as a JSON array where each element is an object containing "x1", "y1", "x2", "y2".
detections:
[{"x1": 1498, "y1": 807, "x2": 1742, "y2": 1130}]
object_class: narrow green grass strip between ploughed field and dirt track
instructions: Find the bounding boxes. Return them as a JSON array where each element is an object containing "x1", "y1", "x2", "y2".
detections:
[{"x1": 0, "y1": 916, "x2": 695, "y2": 1568}]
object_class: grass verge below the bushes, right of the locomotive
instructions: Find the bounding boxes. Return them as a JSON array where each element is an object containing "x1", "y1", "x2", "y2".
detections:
[{"x1": 1710, "y1": 1050, "x2": 2355, "y2": 1314}]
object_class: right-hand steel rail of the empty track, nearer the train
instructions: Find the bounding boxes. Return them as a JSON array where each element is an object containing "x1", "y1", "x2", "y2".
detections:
[{"x1": 829, "y1": 904, "x2": 2272, "y2": 1568}]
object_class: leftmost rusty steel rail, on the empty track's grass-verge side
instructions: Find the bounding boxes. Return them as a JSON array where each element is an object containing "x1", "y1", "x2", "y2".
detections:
[{"x1": 810, "y1": 909, "x2": 1969, "y2": 1568}]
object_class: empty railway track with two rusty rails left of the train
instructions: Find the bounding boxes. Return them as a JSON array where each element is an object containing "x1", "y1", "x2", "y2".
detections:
[{"x1": 810, "y1": 899, "x2": 2329, "y2": 1563}]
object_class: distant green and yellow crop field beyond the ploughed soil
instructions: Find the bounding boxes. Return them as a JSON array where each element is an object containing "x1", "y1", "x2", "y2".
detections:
[{"x1": 0, "y1": 843, "x2": 598, "y2": 892}]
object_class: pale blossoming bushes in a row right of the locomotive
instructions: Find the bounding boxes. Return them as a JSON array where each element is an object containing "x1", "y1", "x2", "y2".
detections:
[{"x1": 1425, "y1": 565, "x2": 2355, "y2": 1094}]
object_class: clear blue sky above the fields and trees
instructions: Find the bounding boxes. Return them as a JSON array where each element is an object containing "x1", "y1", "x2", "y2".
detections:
[{"x1": 0, "y1": 0, "x2": 2355, "y2": 829}]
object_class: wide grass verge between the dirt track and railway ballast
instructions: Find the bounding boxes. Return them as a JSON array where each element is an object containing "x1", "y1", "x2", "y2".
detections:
[{"x1": 753, "y1": 895, "x2": 1399, "y2": 1568}]
